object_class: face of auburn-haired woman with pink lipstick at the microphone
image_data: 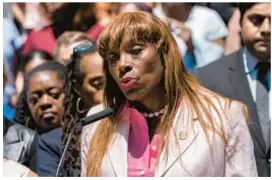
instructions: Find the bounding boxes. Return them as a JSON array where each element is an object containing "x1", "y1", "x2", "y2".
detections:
[{"x1": 107, "y1": 41, "x2": 163, "y2": 101}]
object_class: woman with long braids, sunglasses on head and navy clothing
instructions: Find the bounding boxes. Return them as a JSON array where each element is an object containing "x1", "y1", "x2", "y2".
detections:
[{"x1": 37, "y1": 41, "x2": 104, "y2": 176}]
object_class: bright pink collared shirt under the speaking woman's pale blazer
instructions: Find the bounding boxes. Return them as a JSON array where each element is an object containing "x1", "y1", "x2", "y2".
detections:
[{"x1": 128, "y1": 108, "x2": 162, "y2": 177}]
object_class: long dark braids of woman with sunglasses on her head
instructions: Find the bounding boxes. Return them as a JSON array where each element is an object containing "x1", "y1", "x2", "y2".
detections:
[{"x1": 62, "y1": 41, "x2": 97, "y2": 175}]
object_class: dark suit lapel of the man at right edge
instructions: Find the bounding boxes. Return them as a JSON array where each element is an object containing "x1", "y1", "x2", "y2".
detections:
[{"x1": 228, "y1": 50, "x2": 265, "y2": 151}]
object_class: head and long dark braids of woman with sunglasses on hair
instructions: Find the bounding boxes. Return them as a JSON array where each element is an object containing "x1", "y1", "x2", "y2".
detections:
[{"x1": 62, "y1": 41, "x2": 104, "y2": 175}]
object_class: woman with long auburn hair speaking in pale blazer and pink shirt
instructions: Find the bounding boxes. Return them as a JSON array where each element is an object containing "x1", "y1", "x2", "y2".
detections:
[{"x1": 81, "y1": 12, "x2": 257, "y2": 176}]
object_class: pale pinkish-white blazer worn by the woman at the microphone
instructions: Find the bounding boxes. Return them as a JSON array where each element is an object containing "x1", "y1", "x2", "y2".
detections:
[{"x1": 81, "y1": 97, "x2": 257, "y2": 176}]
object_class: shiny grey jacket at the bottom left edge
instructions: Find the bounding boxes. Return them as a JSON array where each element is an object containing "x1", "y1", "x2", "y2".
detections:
[{"x1": 3, "y1": 118, "x2": 37, "y2": 171}]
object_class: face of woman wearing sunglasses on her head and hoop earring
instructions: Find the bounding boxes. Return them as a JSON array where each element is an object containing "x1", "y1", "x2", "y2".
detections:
[{"x1": 80, "y1": 52, "x2": 105, "y2": 107}]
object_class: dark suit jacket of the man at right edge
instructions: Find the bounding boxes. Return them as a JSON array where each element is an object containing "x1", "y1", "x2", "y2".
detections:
[{"x1": 195, "y1": 49, "x2": 271, "y2": 176}]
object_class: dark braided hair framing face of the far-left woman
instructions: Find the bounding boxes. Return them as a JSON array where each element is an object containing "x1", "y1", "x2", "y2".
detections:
[{"x1": 15, "y1": 61, "x2": 71, "y2": 133}]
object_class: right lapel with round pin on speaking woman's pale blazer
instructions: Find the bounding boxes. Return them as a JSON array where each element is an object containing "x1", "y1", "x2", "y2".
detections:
[{"x1": 155, "y1": 102, "x2": 199, "y2": 176}]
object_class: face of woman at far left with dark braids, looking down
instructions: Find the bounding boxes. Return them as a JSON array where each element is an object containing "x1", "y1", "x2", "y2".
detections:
[{"x1": 27, "y1": 71, "x2": 65, "y2": 130}]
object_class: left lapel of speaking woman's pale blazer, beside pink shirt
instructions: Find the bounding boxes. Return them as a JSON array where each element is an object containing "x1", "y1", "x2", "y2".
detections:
[{"x1": 108, "y1": 111, "x2": 130, "y2": 177}]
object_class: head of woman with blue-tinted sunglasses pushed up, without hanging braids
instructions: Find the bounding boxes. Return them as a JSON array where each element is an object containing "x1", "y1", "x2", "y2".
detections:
[{"x1": 68, "y1": 41, "x2": 104, "y2": 110}]
